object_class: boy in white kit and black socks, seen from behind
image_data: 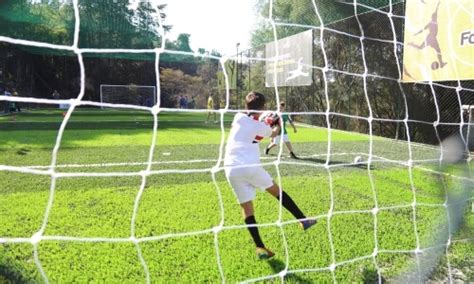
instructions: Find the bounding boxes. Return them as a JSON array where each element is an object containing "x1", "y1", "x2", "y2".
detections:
[{"x1": 224, "y1": 91, "x2": 316, "y2": 259}]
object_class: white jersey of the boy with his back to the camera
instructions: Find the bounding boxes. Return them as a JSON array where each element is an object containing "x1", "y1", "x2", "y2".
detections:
[{"x1": 224, "y1": 113, "x2": 272, "y2": 166}]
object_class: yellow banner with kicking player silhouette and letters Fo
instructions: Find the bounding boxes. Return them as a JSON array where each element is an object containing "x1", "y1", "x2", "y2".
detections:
[{"x1": 403, "y1": 0, "x2": 474, "y2": 82}]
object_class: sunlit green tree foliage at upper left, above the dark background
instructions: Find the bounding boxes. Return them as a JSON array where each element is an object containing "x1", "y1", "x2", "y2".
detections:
[{"x1": 0, "y1": 0, "x2": 170, "y2": 54}]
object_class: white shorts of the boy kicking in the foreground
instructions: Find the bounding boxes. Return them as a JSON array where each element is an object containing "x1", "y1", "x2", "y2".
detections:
[{"x1": 225, "y1": 166, "x2": 273, "y2": 204}]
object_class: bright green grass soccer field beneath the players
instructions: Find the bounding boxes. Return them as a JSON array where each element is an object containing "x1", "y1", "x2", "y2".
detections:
[{"x1": 0, "y1": 109, "x2": 474, "y2": 283}]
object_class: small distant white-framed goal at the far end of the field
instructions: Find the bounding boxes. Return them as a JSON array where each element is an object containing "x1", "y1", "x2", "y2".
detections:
[{"x1": 100, "y1": 84, "x2": 157, "y2": 109}]
